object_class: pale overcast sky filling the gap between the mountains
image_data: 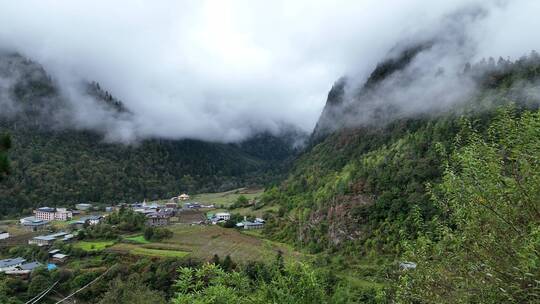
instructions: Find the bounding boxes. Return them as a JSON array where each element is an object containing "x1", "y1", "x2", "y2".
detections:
[{"x1": 0, "y1": 0, "x2": 540, "y2": 141}]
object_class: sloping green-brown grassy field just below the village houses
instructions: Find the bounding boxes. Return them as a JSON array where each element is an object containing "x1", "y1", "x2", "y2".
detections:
[{"x1": 107, "y1": 224, "x2": 305, "y2": 263}]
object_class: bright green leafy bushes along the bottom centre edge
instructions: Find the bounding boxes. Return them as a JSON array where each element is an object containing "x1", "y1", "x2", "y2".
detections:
[{"x1": 172, "y1": 259, "x2": 368, "y2": 304}]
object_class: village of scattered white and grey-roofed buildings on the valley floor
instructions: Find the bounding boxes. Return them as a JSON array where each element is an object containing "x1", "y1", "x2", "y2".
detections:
[{"x1": 0, "y1": 193, "x2": 276, "y2": 279}]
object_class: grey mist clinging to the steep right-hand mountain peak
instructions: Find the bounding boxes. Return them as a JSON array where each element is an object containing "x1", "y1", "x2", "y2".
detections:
[{"x1": 313, "y1": 4, "x2": 538, "y2": 139}]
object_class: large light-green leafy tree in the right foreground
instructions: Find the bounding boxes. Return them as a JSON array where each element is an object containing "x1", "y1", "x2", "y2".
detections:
[{"x1": 398, "y1": 108, "x2": 540, "y2": 303}]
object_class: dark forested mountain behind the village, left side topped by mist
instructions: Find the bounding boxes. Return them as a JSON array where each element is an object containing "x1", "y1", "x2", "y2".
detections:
[{"x1": 0, "y1": 53, "x2": 306, "y2": 215}]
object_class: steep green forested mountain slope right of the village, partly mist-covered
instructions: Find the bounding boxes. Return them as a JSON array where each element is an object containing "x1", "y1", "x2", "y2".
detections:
[{"x1": 264, "y1": 46, "x2": 540, "y2": 255}]
